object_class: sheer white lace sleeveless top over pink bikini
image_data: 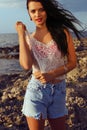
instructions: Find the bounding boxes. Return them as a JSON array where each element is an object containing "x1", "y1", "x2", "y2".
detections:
[{"x1": 26, "y1": 33, "x2": 65, "y2": 80}]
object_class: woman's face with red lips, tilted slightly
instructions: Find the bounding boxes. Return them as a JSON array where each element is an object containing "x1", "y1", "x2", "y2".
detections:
[{"x1": 28, "y1": 1, "x2": 47, "y2": 26}]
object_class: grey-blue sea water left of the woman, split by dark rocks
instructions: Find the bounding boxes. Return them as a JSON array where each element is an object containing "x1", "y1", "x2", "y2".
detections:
[{"x1": 0, "y1": 33, "x2": 23, "y2": 75}]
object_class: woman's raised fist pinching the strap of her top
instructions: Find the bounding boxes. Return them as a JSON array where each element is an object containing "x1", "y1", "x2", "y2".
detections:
[{"x1": 15, "y1": 21, "x2": 26, "y2": 35}]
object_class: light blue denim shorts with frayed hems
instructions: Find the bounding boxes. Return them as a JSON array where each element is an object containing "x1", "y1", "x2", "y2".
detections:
[{"x1": 22, "y1": 76, "x2": 68, "y2": 119}]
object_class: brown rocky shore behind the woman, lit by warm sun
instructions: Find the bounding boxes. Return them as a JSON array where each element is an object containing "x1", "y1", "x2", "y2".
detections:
[{"x1": 0, "y1": 39, "x2": 87, "y2": 130}]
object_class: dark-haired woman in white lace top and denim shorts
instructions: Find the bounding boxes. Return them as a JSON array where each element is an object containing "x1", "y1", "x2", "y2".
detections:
[{"x1": 16, "y1": 0, "x2": 80, "y2": 130}]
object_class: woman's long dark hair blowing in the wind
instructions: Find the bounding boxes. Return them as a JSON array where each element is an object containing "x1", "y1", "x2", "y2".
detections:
[{"x1": 27, "y1": 0, "x2": 81, "y2": 55}]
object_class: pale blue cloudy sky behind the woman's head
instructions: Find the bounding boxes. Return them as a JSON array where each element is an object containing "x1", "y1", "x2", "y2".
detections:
[{"x1": 0, "y1": 0, "x2": 87, "y2": 33}]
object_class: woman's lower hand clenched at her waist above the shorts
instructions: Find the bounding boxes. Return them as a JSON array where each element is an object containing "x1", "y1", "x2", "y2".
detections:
[{"x1": 34, "y1": 71, "x2": 54, "y2": 84}]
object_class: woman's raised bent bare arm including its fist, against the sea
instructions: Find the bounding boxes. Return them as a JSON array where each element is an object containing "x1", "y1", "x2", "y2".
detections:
[{"x1": 16, "y1": 22, "x2": 33, "y2": 70}]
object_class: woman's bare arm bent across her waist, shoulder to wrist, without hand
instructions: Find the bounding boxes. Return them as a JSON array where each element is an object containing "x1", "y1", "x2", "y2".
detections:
[{"x1": 52, "y1": 31, "x2": 77, "y2": 77}]
